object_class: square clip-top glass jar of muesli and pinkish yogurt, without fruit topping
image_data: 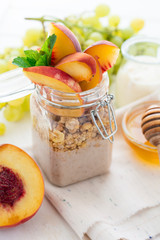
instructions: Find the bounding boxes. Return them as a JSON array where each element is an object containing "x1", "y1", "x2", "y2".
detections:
[{"x1": 31, "y1": 74, "x2": 117, "y2": 186}]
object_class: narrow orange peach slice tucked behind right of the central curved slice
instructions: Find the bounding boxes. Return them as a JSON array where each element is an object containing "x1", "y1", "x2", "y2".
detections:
[{"x1": 79, "y1": 60, "x2": 102, "y2": 91}]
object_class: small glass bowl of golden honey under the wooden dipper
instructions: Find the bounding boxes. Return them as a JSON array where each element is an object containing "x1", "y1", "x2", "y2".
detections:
[{"x1": 122, "y1": 101, "x2": 160, "y2": 164}]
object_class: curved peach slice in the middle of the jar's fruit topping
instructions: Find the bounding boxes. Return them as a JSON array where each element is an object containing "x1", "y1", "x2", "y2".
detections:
[{"x1": 55, "y1": 52, "x2": 96, "y2": 82}]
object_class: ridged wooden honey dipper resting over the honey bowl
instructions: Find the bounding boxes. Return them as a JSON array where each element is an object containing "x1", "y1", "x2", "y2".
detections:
[{"x1": 141, "y1": 105, "x2": 160, "y2": 160}]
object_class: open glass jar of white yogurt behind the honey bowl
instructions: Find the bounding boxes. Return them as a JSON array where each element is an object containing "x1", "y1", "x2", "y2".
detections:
[{"x1": 116, "y1": 36, "x2": 160, "y2": 107}]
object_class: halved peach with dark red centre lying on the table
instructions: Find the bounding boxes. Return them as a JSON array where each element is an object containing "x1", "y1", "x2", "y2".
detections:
[{"x1": 0, "y1": 144, "x2": 44, "y2": 227}]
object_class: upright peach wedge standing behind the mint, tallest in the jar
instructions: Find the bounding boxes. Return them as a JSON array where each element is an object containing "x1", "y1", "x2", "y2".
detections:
[{"x1": 49, "y1": 23, "x2": 81, "y2": 66}]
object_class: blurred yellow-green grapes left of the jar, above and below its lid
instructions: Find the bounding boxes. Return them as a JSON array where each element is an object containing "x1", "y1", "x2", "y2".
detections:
[{"x1": 0, "y1": 29, "x2": 44, "y2": 136}]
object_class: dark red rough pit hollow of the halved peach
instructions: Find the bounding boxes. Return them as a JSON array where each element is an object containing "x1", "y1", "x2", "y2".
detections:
[{"x1": 0, "y1": 165, "x2": 25, "y2": 207}]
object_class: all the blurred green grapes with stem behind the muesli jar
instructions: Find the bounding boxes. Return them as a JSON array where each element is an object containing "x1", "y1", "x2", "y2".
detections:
[{"x1": 0, "y1": 4, "x2": 144, "y2": 135}]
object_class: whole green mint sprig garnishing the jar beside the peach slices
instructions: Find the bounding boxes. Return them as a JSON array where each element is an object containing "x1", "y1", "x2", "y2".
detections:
[{"x1": 12, "y1": 34, "x2": 57, "y2": 68}]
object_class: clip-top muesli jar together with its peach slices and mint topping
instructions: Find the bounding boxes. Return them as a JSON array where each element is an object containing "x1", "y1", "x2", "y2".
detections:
[{"x1": 13, "y1": 23, "x2": 119, "y2": 186}]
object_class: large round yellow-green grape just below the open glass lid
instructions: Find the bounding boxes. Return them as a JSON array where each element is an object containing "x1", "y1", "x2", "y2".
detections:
[{"x1": 3, "y1": 105, "x2": 24, "y2": 122}]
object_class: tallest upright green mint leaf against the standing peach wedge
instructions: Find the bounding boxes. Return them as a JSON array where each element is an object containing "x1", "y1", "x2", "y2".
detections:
[{"x1": 40, "y1": 34, "x2": 57, "y2": 66}]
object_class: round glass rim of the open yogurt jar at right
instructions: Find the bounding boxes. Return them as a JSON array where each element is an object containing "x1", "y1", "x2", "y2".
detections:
[{"x1": 121, "y1": 36, "x2": 160, "y2": 65}]
